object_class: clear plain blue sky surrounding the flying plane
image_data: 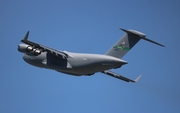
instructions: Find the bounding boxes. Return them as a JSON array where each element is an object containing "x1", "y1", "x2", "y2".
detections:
[{"x1": 0, "y1": 0, "x2": 180, "y2": 113}]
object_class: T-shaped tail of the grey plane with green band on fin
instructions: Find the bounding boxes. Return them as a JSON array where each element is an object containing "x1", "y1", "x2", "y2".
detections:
[{"x1": 106, "y1": 28, "x2": 165, "y2": 58}]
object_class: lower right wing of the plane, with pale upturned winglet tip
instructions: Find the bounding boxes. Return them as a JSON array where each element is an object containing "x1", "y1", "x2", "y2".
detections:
[{"x1": 102, "y1": 70, "x2": 141, "y2": 82}]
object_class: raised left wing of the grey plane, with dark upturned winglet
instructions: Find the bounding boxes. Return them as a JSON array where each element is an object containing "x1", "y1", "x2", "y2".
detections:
[{"x1": 21, "y1": 31, "x2": 68, "y2": 59}]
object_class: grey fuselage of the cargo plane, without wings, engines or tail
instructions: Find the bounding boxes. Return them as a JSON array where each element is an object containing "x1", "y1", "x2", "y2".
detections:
[{"x1": 23, "y1": 52, "x2": 127, "y2": 76}]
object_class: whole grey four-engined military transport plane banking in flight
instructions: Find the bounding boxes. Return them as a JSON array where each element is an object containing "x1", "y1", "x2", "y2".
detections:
[{"x1": 18, "y1": 29, "x2": 165, "y2": 82}]
